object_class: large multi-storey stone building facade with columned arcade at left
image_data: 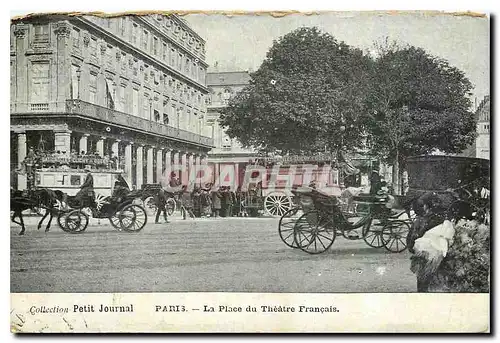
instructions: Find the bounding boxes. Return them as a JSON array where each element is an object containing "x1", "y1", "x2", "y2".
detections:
[{"x1": 10, "y1": 15, "x2": 213, "y2": 189}]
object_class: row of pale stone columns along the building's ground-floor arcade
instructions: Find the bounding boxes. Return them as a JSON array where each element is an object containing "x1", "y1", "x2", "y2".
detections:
[{"x1": 13, "y1": 131, "x2": 207, "y2": 189}]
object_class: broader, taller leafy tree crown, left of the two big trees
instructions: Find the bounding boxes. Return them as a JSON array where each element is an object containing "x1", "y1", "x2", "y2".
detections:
[{"x1": 220, "y1": 28, "x2": 370, "y2": 154}]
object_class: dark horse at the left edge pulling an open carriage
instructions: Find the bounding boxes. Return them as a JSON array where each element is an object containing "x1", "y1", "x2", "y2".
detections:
[{"x1": 10, "y1": 188, "x2": 64, "y2": 235}]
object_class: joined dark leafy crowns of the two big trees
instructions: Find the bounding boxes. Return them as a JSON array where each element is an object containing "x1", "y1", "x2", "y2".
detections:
[{"x1": 220, "y1": 28, "x2": 476, "y2": 167}]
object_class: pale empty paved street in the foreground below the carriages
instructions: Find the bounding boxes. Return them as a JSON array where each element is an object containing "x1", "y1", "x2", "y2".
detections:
[{"x1": 11, "y1": 217, "x2": 416, "y2": 292}]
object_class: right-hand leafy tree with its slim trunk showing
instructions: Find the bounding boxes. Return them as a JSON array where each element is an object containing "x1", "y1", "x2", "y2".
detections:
[{"x1": 363, "y1": 44, "x2": 476, "y2": 192}]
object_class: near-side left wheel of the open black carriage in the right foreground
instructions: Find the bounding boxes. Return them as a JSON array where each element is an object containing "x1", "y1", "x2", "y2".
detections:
[{"x1": 294, "y1": 210, "x2": 336, "y2": 254}]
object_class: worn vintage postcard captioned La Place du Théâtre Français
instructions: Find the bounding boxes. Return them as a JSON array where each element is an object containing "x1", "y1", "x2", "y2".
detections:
[{"x1": 10, "y1": 11, "x2": 491, "y2": 333}]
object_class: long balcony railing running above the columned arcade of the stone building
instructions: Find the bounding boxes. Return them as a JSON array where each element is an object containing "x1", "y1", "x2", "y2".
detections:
[{"x1": 66, "y1": 100, "x2": 214, "y2": 147}]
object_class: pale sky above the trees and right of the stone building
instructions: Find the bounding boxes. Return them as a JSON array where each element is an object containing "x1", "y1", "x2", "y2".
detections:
[{"x1": 184, "y1": 12, "x2": 490, "y2": 101}]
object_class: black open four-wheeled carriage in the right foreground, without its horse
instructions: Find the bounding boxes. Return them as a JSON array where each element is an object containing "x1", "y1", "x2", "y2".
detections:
[{"x1": 279, "y1": 187, "x2": 411, "y2": 254}]
